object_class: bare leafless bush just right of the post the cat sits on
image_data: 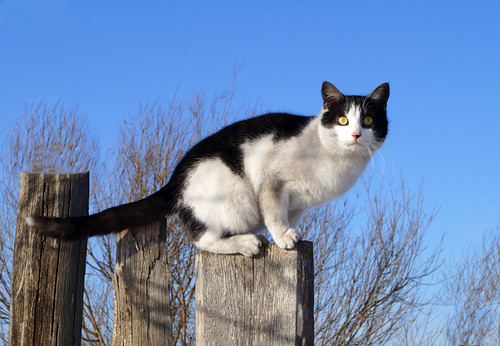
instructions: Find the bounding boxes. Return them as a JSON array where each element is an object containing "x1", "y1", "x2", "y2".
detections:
[{"x1": 302, "y1": 184, "x2": 439, "y2": 345}]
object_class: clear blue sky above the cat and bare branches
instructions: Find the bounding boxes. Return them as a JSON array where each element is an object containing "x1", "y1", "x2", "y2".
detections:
[{"x1": 0, "y1": 0, "x2": 500, "y2": 253}]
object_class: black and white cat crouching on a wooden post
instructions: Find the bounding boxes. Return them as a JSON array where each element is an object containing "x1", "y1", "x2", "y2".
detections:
[{"x1": 26, "y1": 82, "x2": 389, "y2": 256}]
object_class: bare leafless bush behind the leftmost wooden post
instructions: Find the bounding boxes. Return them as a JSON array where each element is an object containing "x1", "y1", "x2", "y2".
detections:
[{"x1": 0, "y1": 102, "x2": 100, "y2": 343}]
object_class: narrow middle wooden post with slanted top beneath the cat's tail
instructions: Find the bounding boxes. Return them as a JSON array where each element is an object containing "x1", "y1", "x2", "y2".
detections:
[{"x1": 113, "y1": 219, "x2": 173, "y2": 346}]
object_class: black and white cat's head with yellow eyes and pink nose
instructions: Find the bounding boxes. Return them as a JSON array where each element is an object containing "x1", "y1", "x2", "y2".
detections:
[{"x1": 319, "y1": 82, "x2": 389, "y2": 156}]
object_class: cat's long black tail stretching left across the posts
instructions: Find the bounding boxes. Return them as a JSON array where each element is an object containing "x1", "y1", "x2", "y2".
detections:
[{"x1": 26, "y1": 188, "x2": 175, "y2": 239}]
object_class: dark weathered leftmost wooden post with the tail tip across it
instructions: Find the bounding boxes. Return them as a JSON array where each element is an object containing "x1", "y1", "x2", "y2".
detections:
[{"x1": 9, "y1": 172, "x2": 89, "y2": 345}]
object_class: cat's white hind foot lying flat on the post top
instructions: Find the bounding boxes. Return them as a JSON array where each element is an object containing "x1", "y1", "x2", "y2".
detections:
[{"x1": 194, "y1": 230, "x2": 267, "y2": 257}]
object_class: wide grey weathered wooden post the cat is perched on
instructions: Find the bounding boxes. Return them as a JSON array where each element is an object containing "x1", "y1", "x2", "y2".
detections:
[{"x1": 196, "y1": 242, "x2": 314, "y2": 346}]
